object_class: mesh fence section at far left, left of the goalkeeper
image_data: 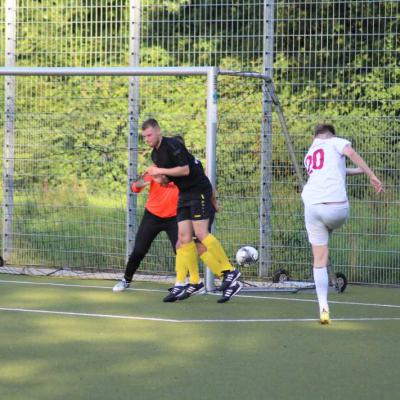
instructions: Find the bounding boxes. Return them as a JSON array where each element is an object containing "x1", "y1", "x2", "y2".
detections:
[{"x1": 0, "y1": 0, "x2": 129, "y2": 271}]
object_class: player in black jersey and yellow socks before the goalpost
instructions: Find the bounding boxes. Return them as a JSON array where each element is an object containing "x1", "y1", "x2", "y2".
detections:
[{"x1": 142, "y1": 119, "x2": 242, "y2": 303}]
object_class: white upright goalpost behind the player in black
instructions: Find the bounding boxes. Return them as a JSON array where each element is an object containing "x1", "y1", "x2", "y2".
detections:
[{"x1": 206, "y1": 68, "x2": 218, "y2": 292}]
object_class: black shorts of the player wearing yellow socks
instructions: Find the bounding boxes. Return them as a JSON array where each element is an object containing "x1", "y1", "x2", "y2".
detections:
[{"x1": 176, "y1": 191, "x2": 214, "y2": 222}]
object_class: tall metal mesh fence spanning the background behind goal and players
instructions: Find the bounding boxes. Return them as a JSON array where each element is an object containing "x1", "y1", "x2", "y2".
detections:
[{"x1": 0, "y1": 0, "x2": 400, "y2": 284}]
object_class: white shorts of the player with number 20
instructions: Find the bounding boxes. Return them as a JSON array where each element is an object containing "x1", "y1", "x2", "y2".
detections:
[{"x1": 304, "y1": 202, "x2": 349, "y2": 246}]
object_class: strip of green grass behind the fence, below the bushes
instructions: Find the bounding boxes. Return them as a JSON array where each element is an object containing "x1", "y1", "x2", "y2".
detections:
[{"x1": 0, "y1": 190, "x2": 400, "y2": 284}]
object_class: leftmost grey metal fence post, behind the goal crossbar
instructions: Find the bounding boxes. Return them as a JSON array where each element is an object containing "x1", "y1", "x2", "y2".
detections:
[{"x1": 3, "y1": 0, "x2": 17, "y2": 263}]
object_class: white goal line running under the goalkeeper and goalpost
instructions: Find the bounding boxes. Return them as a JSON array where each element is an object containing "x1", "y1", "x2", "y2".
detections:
[{"x1": 0, "y1": 279, "x2": 400, "y2": 308}]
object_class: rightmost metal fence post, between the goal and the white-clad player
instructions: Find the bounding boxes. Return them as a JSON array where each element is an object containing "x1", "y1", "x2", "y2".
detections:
[{"x1": 259, "y1": 0, "x2": 275, "y2": 278}]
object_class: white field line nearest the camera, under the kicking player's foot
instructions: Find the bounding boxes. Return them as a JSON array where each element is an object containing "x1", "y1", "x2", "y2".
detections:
[{"x1": 0, "y1": 307, "x2": 400, "y2": 324}]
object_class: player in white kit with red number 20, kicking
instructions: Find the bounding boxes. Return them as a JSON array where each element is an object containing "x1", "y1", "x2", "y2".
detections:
[{"x1": 301, "y1": 125, "x2": 382, "y2": 324}]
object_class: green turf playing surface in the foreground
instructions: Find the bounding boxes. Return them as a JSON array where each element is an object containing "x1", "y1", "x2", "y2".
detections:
[{"x1": 0, "y1": 274, "x2": 400, "y2": 400}]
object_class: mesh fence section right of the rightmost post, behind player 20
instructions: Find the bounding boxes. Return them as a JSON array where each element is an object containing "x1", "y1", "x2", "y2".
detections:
[{"x1": 273, "y1": 1, "x2": 400, "y2": 283}]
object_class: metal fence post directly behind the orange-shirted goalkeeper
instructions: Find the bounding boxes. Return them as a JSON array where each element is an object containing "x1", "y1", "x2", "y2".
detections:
[{"x1": 126, "y1": 0, "x2": 140, "y2": 261}]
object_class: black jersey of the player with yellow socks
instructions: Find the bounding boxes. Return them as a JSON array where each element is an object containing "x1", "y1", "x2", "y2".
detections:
[{"x1": 151, "y1": 137, "x2": 212, "y2": 192}]
